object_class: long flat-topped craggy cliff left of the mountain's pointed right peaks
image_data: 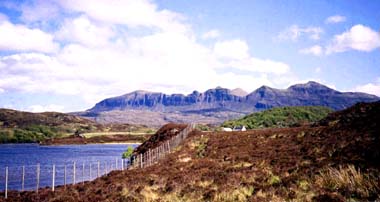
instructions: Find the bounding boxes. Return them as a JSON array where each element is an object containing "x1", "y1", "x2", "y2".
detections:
[{"x1": 88, "y1": 87, "x2": 245, "y2": 112}]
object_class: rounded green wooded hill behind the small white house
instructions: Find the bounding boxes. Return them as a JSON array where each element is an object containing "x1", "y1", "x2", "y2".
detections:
[{"x1": 222, "y1": 106, "x2": 332, "y2": 129}]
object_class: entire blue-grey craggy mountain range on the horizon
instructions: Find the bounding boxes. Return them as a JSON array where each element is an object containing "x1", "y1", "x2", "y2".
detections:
[{"x1": 75, "y1": 81, "x2": 380, "y2": 126}]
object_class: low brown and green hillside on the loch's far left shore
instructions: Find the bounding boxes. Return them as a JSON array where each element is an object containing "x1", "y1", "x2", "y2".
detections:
[{"x1": 0, "y1": 109, "x2": 151, "y2": 143}]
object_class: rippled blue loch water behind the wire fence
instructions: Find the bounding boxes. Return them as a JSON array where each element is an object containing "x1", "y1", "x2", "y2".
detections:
[{"x1": 0, "y1": 144, "x2": 138, "y2": 190}]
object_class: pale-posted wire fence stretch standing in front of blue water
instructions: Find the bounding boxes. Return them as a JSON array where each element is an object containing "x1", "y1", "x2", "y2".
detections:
[{"x1": 0, "y1": 158, "x2": 130, "y2": 198}]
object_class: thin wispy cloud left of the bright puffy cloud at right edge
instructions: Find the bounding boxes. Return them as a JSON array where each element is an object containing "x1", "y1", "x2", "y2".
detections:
[{"x1": 277, "y1": 25, "x2": 323, "y2": 41}]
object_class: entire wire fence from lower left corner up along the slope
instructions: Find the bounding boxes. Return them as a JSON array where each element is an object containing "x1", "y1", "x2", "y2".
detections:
[{"x1": 0, "y1": 124, "x2": 195, "y2": 198}]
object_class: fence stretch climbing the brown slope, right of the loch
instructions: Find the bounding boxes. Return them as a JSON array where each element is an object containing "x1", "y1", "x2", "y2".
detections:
[{"x1": 130, "y1": 124, "x2": 195, "y2": 168}]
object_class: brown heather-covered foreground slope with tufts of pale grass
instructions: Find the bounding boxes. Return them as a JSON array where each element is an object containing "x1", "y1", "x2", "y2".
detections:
[{"x1": 6, "y1": 102, "x2": 380, "y2": 202}]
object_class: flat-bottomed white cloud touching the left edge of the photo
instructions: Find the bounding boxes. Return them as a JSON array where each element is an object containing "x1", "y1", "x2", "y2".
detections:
[{"x1": 0, "y1": 21, "x2": 58, "y2": 53}]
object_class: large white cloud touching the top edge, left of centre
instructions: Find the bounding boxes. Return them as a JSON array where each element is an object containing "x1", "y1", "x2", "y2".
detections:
[{"x1": 57, "y1": 0, "x2": 188, "y2": 33}]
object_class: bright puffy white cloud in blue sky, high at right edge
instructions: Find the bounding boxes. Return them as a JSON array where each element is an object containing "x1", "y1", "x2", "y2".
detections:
[{"x1": 326, "y1": 24, "x2": 380, "y2": 54}]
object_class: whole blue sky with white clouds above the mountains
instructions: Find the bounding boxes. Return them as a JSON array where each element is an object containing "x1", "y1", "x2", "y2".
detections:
[{"x1": 0, "y1": 0, "x2": 380, "y2": 112}]
